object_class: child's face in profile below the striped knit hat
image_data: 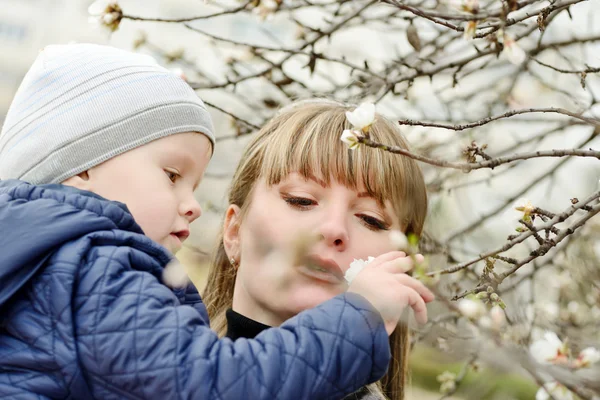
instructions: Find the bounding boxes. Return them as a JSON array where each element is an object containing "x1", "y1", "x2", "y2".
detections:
[{"x1": 72, "y1": 133, "x2": 211, "y2": 253}]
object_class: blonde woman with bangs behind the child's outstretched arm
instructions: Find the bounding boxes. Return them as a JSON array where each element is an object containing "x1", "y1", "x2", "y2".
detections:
[{"x1": 204, "y1": 101, "x2": 433, "y2": 399}]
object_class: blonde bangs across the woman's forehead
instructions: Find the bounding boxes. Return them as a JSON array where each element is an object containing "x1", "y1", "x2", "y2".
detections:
[{"x1": 251, "y1": 102, "x2": 427, "y2": 234}]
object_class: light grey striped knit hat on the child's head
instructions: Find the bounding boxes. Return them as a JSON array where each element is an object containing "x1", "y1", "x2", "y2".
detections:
[{"x1": 0, "y1": 44, "x2": 214, "y2": 184}]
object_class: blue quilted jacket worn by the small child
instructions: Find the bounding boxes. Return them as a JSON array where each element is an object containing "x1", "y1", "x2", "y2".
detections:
[{"x1": 0, "y1": 180, "x2": 389, "y2": 399}]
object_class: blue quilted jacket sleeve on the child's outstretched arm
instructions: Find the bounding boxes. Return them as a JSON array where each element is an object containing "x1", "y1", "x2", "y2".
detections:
[{"x1": 75, "y1": 250, "x2": 389, "y2": 400}]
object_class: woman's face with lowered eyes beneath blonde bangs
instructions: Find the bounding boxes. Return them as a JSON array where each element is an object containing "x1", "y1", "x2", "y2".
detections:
[{"x1": 224, "y1": 173, "x2": 401, "y2": 326}]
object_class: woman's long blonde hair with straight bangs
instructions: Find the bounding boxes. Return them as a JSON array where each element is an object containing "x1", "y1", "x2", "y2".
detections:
[{"x1": 203, "y1": 101, "x2": 427, "y2": 399}]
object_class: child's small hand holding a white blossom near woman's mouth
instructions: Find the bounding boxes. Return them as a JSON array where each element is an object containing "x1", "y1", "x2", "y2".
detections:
[{"x1": 348, "y1": 251, "x2": 435, "y2": 335}]
